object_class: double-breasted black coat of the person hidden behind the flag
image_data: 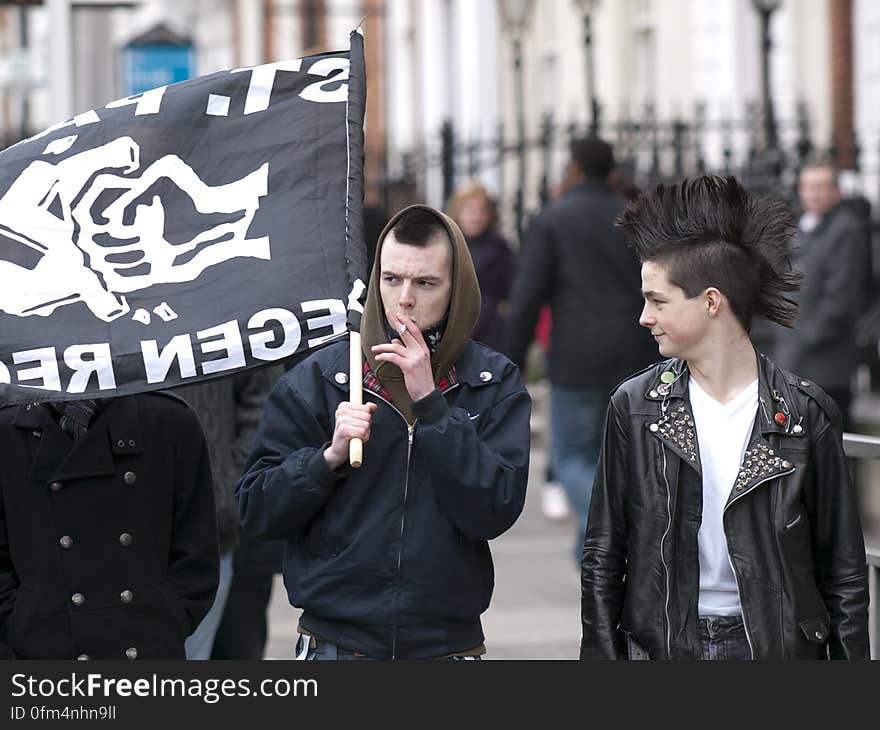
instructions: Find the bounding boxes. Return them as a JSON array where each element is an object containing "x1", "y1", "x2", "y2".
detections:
[{"x1": 0, "y1": 393, "x2": 218, "y2": 659}]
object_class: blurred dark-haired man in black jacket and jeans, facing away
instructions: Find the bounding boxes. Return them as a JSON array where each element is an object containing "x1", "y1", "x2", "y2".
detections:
[{"x1": 507, "y1": 137, "x2": 655, "y2": 564}]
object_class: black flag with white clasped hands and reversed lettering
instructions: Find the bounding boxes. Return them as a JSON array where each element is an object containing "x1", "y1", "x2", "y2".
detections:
[{"x1": 0, "y1": 32, "x2": 366, "y2": 402}]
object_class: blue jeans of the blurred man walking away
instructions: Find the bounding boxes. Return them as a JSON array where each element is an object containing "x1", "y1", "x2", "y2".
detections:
[{"x1": 550, "y1": 385, "x2": 608, "y2": 566}]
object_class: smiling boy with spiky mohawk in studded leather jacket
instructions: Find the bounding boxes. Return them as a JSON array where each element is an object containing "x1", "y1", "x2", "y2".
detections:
[{"x1": 581, "y1": 177, "x2": 869, "y2": 659}]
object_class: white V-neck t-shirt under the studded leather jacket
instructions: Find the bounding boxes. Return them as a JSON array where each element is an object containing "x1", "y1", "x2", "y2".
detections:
[{"x1": 689, "y1": 377, "x2": 758, "y2": 616}]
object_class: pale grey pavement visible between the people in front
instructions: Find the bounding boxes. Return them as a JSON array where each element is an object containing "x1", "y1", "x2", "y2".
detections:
[{"x1": 266, "y1": 385, "x2": 580, "y2": 659}]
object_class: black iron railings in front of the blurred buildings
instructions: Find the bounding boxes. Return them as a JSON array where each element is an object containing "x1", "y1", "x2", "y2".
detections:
[{"x1": 382, "y1": 104, "x2": 880, "y2": 245}]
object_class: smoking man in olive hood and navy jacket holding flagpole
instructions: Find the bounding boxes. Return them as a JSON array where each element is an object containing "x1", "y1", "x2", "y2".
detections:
[{"x1": 238, "y1": 205, "x2": 530, "y2": 659}]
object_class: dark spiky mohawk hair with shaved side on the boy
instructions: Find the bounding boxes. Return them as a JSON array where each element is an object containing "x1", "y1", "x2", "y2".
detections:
[{"x1": 617, "y1": 175, "x2": 803, "y2": 332}]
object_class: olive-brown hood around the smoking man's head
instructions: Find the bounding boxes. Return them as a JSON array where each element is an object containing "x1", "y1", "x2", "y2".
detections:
[{"x1": 361, "y1": 205, "x2": 480, "y2": 423}]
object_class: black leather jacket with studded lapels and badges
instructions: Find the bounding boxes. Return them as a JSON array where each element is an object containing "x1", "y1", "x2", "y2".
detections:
[{"x1": 581, "y1": 355, "x2": 869, "y2": 659}]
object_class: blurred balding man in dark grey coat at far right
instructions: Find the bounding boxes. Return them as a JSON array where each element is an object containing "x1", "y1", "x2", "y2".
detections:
[{"x1": 773, "y1": 161, "x2": 870, "y2": 430}]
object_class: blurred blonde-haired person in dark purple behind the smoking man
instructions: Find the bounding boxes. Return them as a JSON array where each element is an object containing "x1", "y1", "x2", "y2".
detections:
[{"x1": 447, "y1": 181, "x2": 516, "y2": 350}]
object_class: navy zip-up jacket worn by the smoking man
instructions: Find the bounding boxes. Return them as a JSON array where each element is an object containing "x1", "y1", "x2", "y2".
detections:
[{"x1": 238, "y1": 341, "x2": 531, "y2": 659}]
